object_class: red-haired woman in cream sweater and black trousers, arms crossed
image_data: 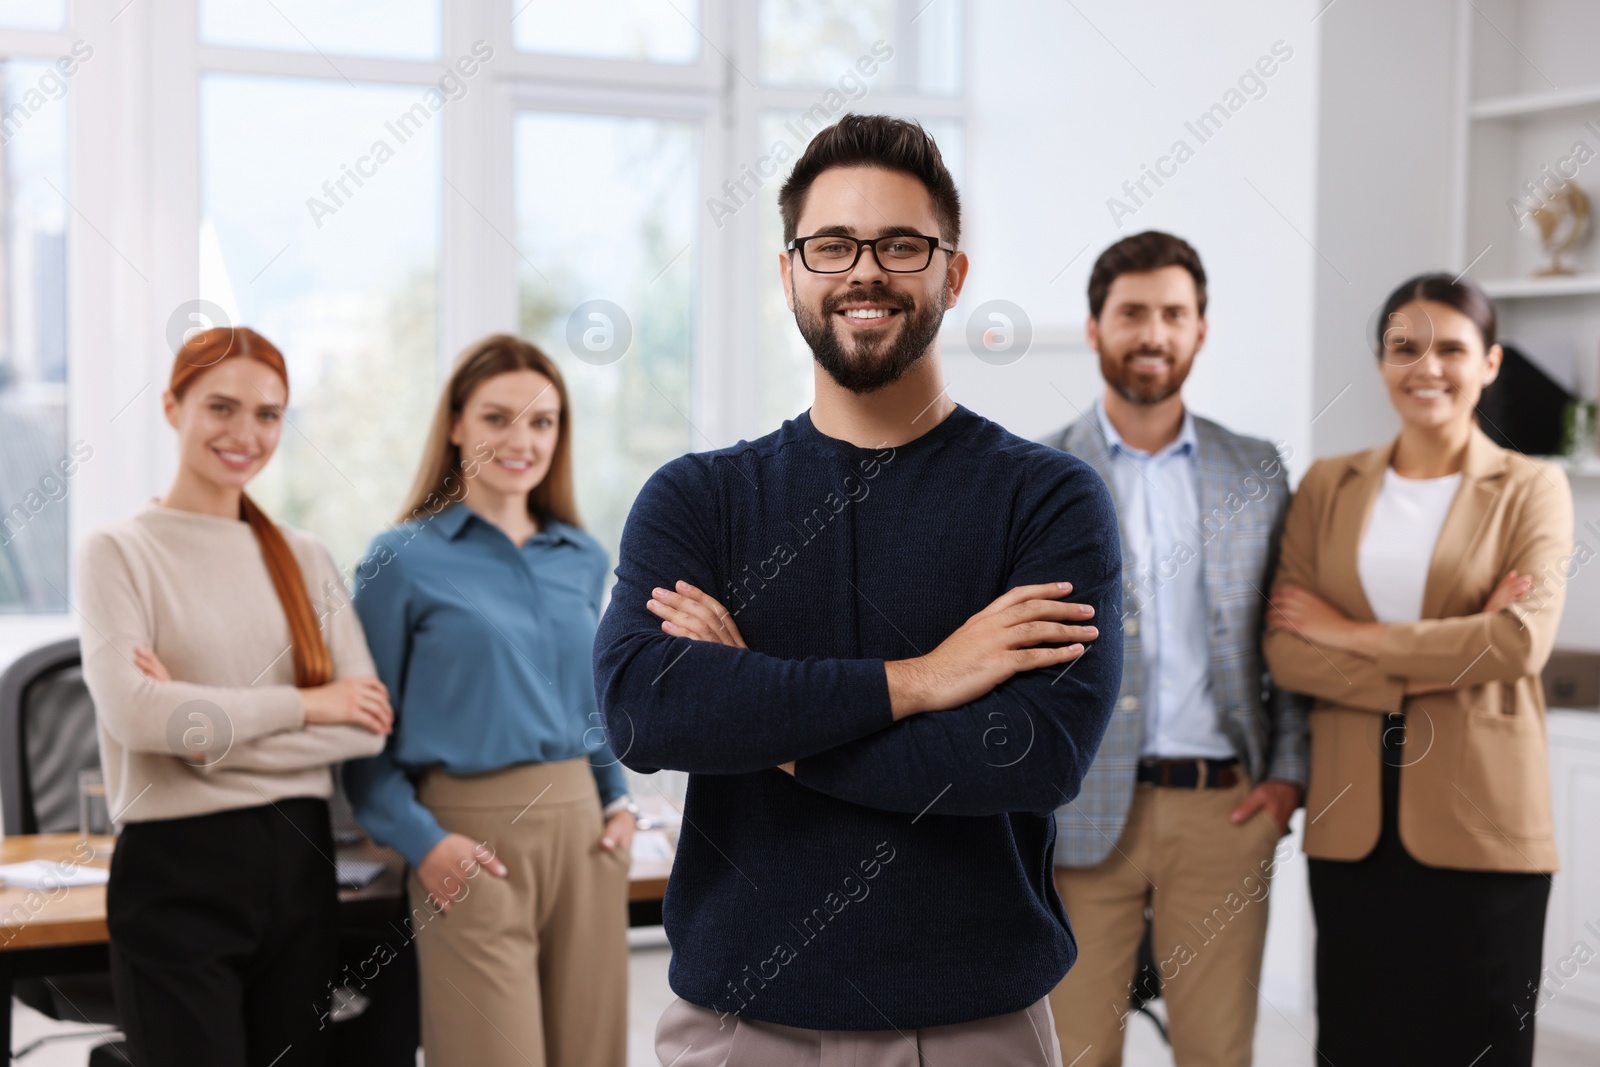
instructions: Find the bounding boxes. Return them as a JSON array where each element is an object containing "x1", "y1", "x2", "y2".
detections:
[{"x1": 78, "y1": 328, "x2": 394, "y2": 1067}]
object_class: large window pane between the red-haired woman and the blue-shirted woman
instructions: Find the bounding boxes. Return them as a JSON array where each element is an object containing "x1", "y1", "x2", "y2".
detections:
[{"x1": 198, "y1": 74, "x2": 443, "y2": 566}]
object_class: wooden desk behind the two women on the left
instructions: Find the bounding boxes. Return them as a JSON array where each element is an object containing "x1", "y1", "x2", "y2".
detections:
[{"x1": 0, "y1": 833, "x2": 672, "y2": 1061}]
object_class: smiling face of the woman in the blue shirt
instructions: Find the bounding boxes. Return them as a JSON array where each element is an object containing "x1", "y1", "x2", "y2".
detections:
[{"x1": 450, "y1": 371, "x2": 562, "y2": 496}]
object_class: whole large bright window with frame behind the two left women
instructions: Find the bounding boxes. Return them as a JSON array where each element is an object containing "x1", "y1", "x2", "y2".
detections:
[{"x1": 34, "y1": 0, "x2": 965, "y2": 613}]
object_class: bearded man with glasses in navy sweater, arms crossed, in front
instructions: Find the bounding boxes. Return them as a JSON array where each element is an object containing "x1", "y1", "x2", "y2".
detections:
[{"x1": 595, "y1": 115, "x2": 1122, "y2": 1067}]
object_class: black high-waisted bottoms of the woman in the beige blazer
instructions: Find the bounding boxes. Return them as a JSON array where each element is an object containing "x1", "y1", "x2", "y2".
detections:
[{"x1": 1310, "y1": 715, "x2": 1550, "y2": 1067}]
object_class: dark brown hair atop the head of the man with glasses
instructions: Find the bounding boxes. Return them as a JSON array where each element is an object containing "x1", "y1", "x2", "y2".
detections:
[{"x1": 778, "y1": 114, "x2": 962, "y2": 246}]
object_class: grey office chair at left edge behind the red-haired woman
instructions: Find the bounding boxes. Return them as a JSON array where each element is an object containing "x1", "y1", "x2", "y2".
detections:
[{"x1": 0, "y1": 638, "x2": 128, "y2": 1067}]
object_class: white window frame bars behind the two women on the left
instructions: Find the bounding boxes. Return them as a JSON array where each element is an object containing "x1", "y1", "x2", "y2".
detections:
[{"x1": 43, "y1": 0, "x2": 974, "y2": 633}]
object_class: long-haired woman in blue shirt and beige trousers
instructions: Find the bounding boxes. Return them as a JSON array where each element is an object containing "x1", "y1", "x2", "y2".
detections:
[{"x1": 344, "y1": 336, "x2": 635, "y2": 1067}]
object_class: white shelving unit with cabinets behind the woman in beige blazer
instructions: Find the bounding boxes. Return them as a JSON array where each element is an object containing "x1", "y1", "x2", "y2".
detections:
[{"x1": 1459, "y1": 0, "x2": 1600, "y2": 1041}]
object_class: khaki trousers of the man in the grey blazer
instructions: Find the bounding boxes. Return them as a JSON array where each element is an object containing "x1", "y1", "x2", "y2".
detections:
[{"x1": 1050, "y1": 782, "x2": 1278, "y2": 1067}]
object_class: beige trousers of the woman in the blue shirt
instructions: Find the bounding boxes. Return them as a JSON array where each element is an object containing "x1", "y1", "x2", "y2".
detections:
[{"x1": 408, "y1": 760, "x2": 630, "y2": 1067}]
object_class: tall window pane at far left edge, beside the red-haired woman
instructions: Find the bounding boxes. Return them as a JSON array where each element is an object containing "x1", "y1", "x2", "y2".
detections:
[{"x1": 0, "y1": 56, "x2": 71, "y2": 613}]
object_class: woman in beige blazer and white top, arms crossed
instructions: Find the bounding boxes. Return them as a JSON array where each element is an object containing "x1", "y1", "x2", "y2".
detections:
[{"x1": 1266, "y1": 274, "x2": 1573, "y2": 1067}]
